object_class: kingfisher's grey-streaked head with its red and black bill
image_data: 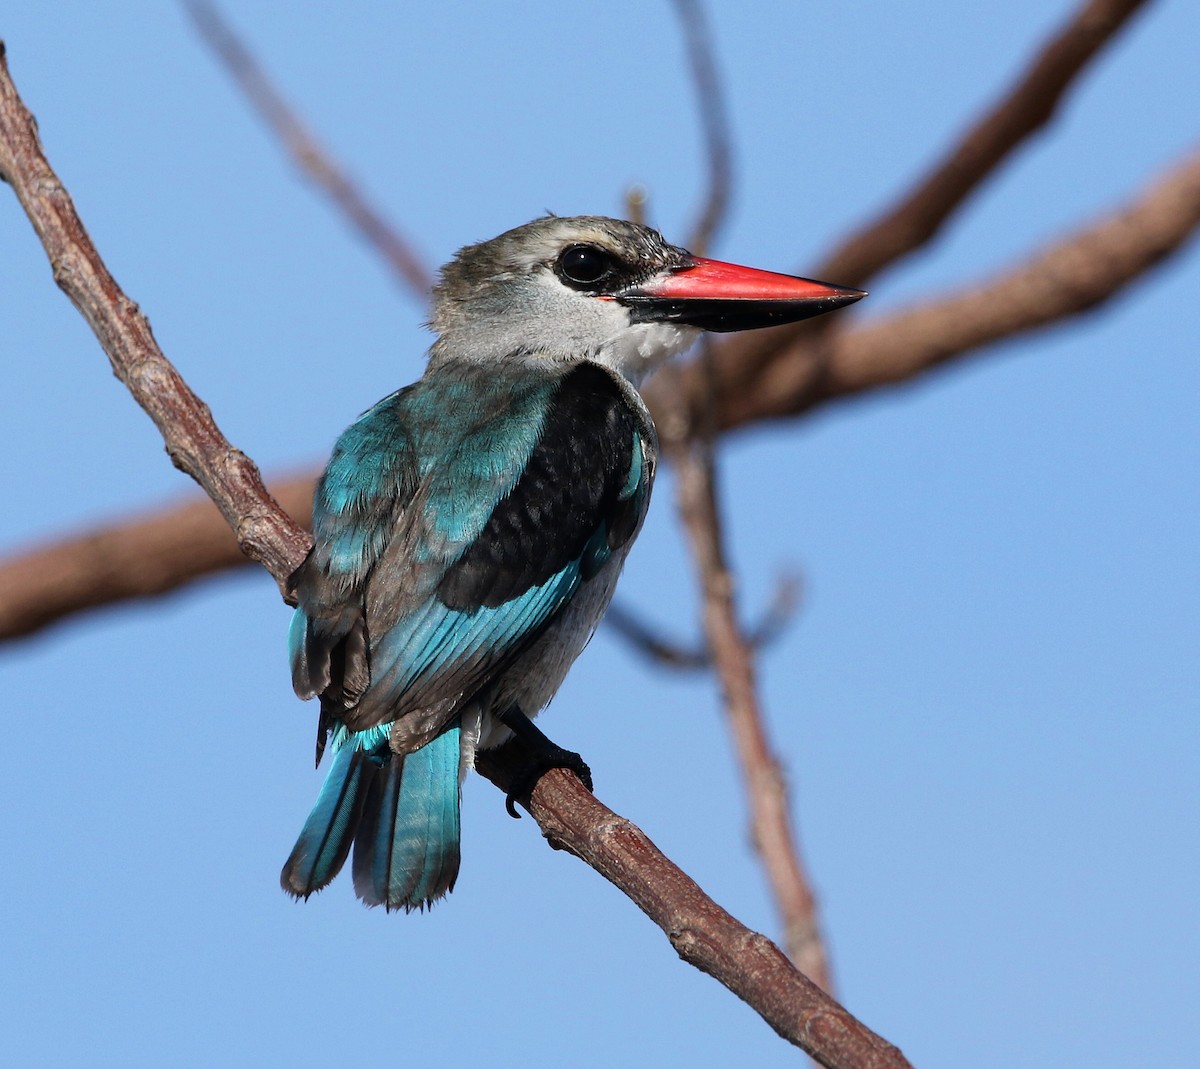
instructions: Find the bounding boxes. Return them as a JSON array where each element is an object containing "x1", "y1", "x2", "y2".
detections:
[{"x1": 431, "y1": 216, "x2": 864, "y2": 382}]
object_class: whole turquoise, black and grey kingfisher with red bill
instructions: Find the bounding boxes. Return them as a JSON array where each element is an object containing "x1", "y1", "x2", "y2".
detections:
[{"x1": 281, "y1": 215, "x2": 864, "y2": 911}]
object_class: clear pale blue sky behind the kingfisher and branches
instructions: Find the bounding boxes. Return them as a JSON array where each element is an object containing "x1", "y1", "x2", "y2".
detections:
[{"x1": 0, "y1": 0, "x2": 1200, "y2": 1069}]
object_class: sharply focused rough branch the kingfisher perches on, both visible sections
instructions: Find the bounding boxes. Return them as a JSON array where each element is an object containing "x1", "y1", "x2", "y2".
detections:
[{"x1": 0, "y1": 42, "x2": 907, "y2": 1069}]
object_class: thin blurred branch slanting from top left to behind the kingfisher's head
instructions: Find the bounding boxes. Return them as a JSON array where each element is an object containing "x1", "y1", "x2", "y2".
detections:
[{"x1": 184, "y1": 0, "x2": 433, "y2": 302}]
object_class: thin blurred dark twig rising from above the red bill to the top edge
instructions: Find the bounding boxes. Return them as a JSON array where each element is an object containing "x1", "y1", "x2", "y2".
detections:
[{"x1": 674, "y1": 0, "x2": 733, "y2": 254}]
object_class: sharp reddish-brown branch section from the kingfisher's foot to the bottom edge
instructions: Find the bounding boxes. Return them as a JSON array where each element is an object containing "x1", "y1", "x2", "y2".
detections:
[{"x1": 476, "y1": 746, "x2": 908, "y2": 1069}]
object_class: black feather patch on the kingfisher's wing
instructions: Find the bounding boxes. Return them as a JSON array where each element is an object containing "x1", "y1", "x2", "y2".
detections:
[{"x1": 438, "y1": 364, "x2": 644, "y2": 612}]
